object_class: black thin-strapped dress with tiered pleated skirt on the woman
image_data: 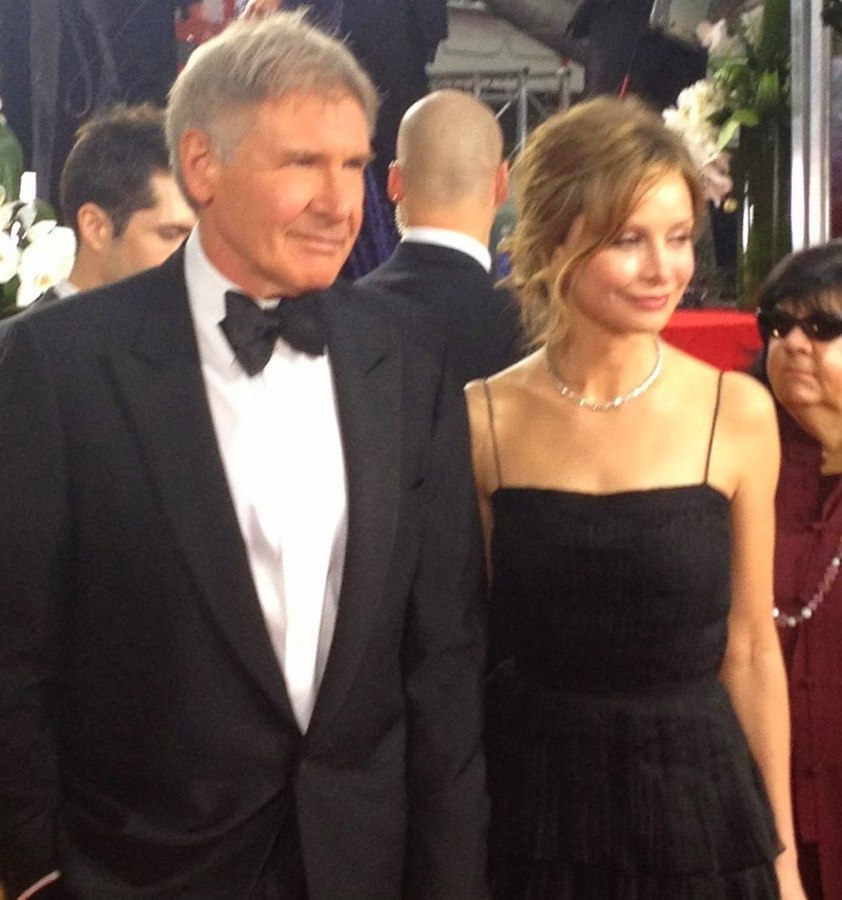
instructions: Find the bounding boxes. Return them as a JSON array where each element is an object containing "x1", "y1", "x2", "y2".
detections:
[{"x1": 487, "y1": 484, "x2": 779, "y2": 900}]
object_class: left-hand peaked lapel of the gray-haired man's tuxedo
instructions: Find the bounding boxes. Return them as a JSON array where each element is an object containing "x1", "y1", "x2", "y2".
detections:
[{"x1": 105, "y1": 254, "x2": 294, "y2": 721}]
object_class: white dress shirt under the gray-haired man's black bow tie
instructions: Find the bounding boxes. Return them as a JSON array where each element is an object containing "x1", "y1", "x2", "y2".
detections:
[{"x1": 185, "y1": 227, "x2": 347, "y2": 732}]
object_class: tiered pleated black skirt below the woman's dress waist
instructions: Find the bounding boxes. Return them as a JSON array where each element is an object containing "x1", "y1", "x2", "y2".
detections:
[{"x1": 487, "y1": 664, "x2": 780, "y2": 900}]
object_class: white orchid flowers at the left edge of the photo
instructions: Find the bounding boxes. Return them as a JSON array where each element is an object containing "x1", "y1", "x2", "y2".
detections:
[{"x1": 0, "y1": 104, "x2": 76, "y2": 317}]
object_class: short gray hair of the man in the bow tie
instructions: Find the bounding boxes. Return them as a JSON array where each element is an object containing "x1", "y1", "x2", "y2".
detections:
[{"x1": 166, "y1": 10, "x2": 379, "y2": 196}]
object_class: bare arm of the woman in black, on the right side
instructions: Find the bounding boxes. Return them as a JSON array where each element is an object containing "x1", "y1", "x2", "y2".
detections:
[{"x1": 714, "y1": 374, "x2": 804, "y2": 900}]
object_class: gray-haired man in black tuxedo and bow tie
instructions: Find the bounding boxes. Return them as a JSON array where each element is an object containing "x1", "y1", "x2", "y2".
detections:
[{"x1": 0, "y1": 13, "x2": 487, "y2": 900}]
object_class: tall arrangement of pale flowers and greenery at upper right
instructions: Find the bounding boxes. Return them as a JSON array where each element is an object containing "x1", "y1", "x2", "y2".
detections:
[{"x1": 664, "y1": 0, "x2": 791, "y2": 304}]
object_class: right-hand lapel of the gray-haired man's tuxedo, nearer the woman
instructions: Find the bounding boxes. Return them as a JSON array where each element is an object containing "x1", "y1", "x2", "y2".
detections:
[{"x1": 308, "y1": 291, "x2": 402, "y2": 735}]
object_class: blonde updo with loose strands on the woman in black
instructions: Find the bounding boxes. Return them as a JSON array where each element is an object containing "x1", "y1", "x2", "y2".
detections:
[{"x1": 504, "y1": 97, "x2": 704, "y2": 344}]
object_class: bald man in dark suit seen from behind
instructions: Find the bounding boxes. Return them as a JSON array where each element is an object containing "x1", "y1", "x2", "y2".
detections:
[{"x1": 357, "y1": 90, "x2": 522, "y2": 385}]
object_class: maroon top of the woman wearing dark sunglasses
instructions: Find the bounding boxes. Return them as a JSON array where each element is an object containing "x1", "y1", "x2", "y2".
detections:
[{"x1": 775, "y1": 410, "x2": 842, "y2": 900}]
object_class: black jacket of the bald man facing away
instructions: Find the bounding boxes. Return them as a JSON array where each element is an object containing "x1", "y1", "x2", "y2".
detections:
[{"x1": 357, "y1": 241, "x2": 523, "y2": 386}]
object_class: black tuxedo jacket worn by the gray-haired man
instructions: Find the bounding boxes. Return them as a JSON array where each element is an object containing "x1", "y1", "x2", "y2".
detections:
[{"x1": 0, "y1": 252, "x2": 487, "y2": 900}]
